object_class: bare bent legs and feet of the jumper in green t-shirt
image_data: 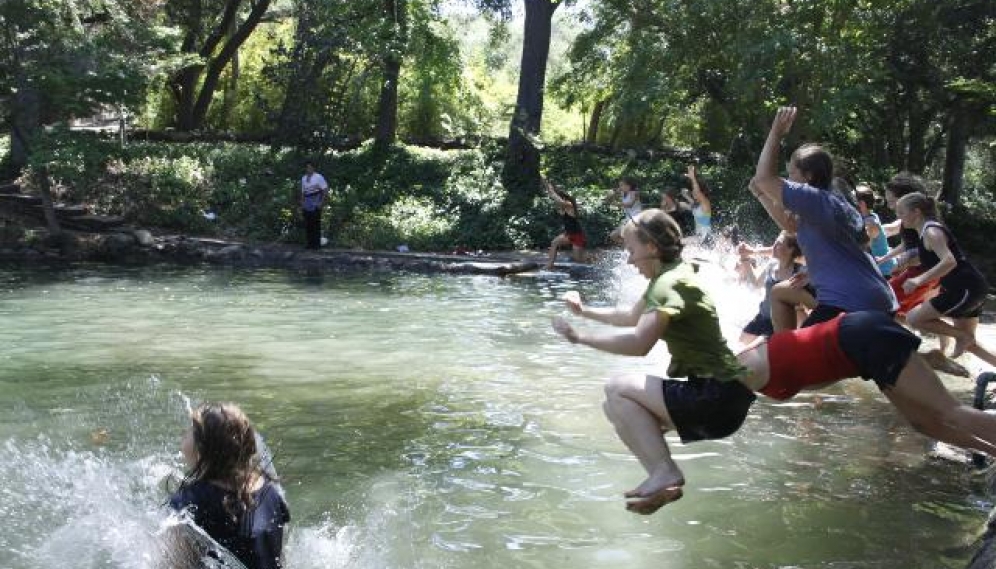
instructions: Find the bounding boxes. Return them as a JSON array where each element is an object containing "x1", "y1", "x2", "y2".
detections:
[{"x1": 602, "y1": 374, "x2": 685, "y2": 514}]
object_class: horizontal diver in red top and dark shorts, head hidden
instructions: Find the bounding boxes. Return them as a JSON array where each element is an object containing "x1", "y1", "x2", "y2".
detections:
[{"x1": 737, "y1": 312, "x2": 996, "y2": 456}]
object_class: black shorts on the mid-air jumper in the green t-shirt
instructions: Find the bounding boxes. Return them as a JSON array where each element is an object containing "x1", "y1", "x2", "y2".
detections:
[{"x1": 664, "y1": 377, "x2": 757, "y2": 443}]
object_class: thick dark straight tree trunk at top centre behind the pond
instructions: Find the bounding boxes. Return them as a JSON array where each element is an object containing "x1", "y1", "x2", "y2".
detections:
[{"x1": 502, "y1": 0, "x2": 560, "y2": 204}]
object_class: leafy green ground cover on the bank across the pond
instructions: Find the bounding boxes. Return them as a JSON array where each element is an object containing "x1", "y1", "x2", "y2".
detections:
[{"x1": 19, "y1": 132, "x2": 996, "y2": 282}]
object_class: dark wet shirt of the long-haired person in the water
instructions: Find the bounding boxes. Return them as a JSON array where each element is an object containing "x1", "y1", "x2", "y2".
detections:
[{"x1": 169, "y1": 480, "x2": 290, "y2": 569}]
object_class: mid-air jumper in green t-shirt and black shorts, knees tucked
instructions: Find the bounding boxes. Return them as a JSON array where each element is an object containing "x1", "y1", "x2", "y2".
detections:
[{"x1": 553, "y1": 209, "x2": 755, "y2": 514}]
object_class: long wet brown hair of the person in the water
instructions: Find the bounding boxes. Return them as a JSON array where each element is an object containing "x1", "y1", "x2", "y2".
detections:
[{"x1": 180, "y1": 403, "x2": 257, "y2": 519}]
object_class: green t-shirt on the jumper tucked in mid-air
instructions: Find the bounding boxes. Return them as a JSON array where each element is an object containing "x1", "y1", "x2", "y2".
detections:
[{"x1": 643, "y1": 261, "x2": 747, "y2": 381}]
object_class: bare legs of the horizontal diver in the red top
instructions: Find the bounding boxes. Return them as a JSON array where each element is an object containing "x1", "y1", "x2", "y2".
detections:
[{"x1": 883, "y1": 354, "x2": 996, "y2": 456}]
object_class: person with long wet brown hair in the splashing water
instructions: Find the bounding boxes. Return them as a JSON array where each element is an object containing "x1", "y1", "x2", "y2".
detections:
[{"x1": 169, "y1": 404, "x2": 290, "y2": 569}]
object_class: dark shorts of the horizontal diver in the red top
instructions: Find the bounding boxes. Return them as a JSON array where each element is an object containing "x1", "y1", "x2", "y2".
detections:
[{"x1": 837, "y1": 312, "x2": 920, "y2": 389}]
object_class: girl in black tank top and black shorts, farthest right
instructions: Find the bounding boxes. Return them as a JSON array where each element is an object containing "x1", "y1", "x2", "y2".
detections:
[{"x1": 896, "y1": 192, "x2": 996, "y2": 365}]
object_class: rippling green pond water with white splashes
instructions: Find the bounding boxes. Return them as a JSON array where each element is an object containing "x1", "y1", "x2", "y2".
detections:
[{"x1": 0, "y1": 254, "x2": 992, "y2": 569}]
